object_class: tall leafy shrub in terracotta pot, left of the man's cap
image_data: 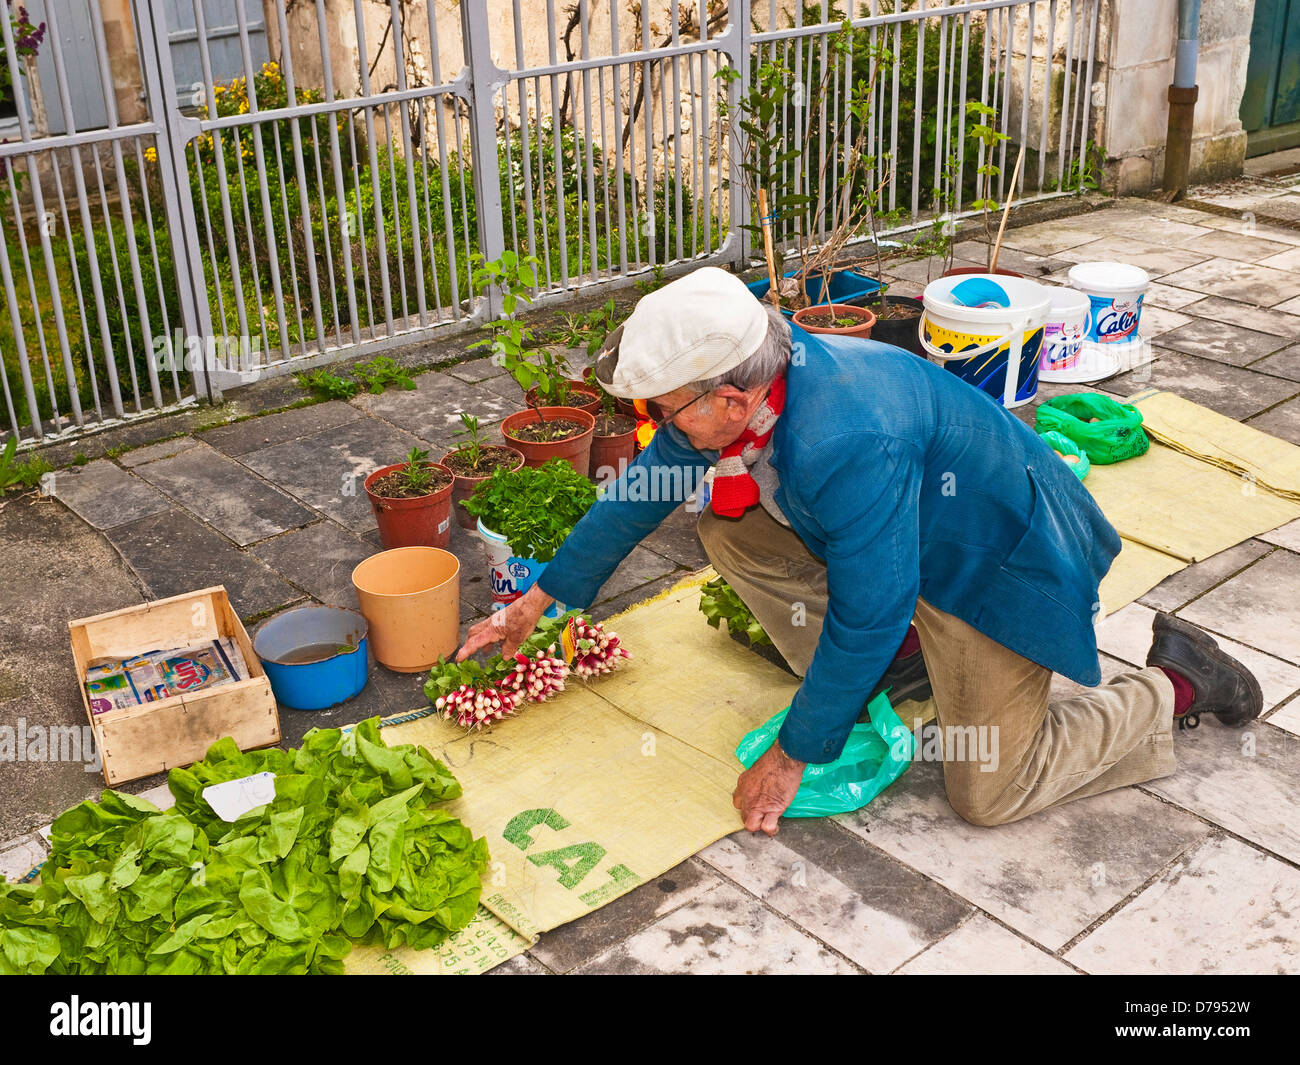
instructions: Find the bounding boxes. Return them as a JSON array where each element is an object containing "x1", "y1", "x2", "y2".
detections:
[{"x1": 471, "y1": 251, "x2": 599, "y2": 477}]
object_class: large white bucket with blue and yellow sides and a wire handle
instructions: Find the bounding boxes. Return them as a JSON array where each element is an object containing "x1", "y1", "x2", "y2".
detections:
[{"x1": 920, "y1": 274, "x2": 1052, "y2": 407}]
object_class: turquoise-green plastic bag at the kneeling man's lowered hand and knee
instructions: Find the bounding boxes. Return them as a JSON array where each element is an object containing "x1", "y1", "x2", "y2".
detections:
[{"x1": 736, "y1": 692, "x2": 917, "y2": 817}]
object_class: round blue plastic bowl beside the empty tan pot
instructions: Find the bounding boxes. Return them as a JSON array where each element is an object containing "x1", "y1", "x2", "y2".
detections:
[{"x1": 252, "y1": 606, "x2": 369, "y2": 710}]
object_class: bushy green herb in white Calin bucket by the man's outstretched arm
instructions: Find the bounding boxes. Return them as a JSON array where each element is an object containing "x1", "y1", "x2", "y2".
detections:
[{"x1": 460, "y1": 459, "x2": 595, "y2": 618}]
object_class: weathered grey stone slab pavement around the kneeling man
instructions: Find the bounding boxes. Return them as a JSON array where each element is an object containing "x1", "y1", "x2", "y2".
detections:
[{"x1": 0, "y1": 176, "x2": 1300, "y2": 974}]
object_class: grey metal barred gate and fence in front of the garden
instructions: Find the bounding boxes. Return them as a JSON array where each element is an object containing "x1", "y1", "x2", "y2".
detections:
[{"x1": 0, "y1": 0, "x2": 1101, "y2": 443}]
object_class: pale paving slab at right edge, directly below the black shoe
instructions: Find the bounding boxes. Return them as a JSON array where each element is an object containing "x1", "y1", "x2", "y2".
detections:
[{"x1": 1140, "y1": 715, "x2": 1300, "y2": 862}]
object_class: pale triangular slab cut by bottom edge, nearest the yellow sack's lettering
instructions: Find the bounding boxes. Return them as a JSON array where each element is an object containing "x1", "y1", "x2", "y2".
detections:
[{"x1": 577, "y1": 884, "x2": 858, "y2": 975}]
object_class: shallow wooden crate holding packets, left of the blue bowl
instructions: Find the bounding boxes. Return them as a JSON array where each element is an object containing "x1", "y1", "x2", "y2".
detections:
[{"x1": 68, "y1": 585, "x2": 280, "y2": 784}]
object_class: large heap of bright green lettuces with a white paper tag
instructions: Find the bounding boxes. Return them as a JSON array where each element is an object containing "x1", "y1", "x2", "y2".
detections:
[{"x1": 0, "y1": 718, "x2": 488, "y2": 975}]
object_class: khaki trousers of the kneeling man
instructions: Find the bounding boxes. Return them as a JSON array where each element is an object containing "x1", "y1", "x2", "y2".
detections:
[{"x1": 699, "y1": 507, "x2": 1174, "y2": 824}]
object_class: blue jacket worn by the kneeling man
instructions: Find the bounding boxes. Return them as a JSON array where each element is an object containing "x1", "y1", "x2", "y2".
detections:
[{"x1": 538, "y1": 326, "x2": 1119, "y2": 762}]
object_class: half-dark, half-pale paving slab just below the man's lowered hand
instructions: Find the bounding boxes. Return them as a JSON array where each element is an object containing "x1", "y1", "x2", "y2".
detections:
[{"x1": 699, "y1": 818, "x2": 971, "y2": 973}]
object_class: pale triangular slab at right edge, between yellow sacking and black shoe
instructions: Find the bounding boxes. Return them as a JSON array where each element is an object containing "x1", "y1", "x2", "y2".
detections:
[{"x1": 1178, "y1": 551, "x2": 1300, "y2": 664}]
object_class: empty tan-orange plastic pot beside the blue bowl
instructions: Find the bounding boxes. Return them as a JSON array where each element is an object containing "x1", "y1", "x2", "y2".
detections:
[{"x1": 352, "y1": 547, "x2": 460, "y2": 674}]
